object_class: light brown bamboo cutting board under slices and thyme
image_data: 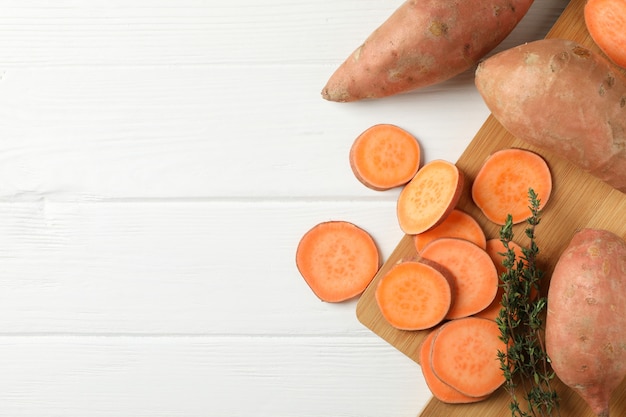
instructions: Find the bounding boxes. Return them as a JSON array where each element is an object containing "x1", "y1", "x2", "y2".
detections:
[{"x1": 357, "y1": 0, "x2": 626, "y2": 417}]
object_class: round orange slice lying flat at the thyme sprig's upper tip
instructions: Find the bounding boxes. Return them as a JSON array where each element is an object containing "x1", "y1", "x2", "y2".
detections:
[{"x1": 472, "y1": 148, "x2": 552, "y2": 225}]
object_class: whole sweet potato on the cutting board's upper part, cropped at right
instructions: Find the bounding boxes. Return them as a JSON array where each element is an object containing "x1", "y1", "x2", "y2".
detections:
[{"x1": 475, "y1": 39, "x2": 626, "y2": 192}]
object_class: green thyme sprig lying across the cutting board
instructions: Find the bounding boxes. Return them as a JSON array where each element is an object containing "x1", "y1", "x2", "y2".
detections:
[{"x1": 496, "y1": 188, "x2": 559, "y2": 417}]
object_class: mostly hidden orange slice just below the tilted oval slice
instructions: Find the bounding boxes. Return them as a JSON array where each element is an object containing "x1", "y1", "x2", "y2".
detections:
[{"x1": 413, "y1": 209, "x2": 487, "y2": 253}]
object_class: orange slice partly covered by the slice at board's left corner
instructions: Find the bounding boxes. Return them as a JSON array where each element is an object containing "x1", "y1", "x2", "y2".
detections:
[{"x1": 420, "y1": 238, "x2": 498, "y2": 320}]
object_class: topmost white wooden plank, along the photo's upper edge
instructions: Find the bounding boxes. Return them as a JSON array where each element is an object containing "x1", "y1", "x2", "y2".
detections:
[{"x1": 0, "y1": 0, "x2": 563, "y2": 66}]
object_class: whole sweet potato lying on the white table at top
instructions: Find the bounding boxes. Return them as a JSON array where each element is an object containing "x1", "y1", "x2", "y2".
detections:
[{"x1": 322, "y1": 0, "x2": 533, "y2": 102}]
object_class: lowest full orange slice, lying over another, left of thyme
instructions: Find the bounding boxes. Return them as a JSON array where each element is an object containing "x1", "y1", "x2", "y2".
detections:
[{"x1": 430, "y1": 317, "x2": 506, "y2": 397}]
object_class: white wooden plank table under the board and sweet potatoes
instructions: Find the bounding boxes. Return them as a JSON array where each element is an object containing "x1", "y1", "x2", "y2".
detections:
[{"x1": 0, "y1": 0, "x2": 567, "y2": 417}]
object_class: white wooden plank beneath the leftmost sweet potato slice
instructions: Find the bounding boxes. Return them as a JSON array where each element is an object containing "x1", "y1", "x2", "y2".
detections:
[{"x1": 0, "y1": 199, "x2": 401, "y2": 335}]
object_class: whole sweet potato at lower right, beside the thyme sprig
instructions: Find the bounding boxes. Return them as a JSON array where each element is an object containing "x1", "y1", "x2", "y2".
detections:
[{"x1": 545, "y1": 229, "x2": 626, "y2": 417}]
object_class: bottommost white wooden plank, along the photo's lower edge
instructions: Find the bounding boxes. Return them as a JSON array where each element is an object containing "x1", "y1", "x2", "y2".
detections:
[{"x1": 0, "y1": 333, "x2": 427, "y2": 417}]
